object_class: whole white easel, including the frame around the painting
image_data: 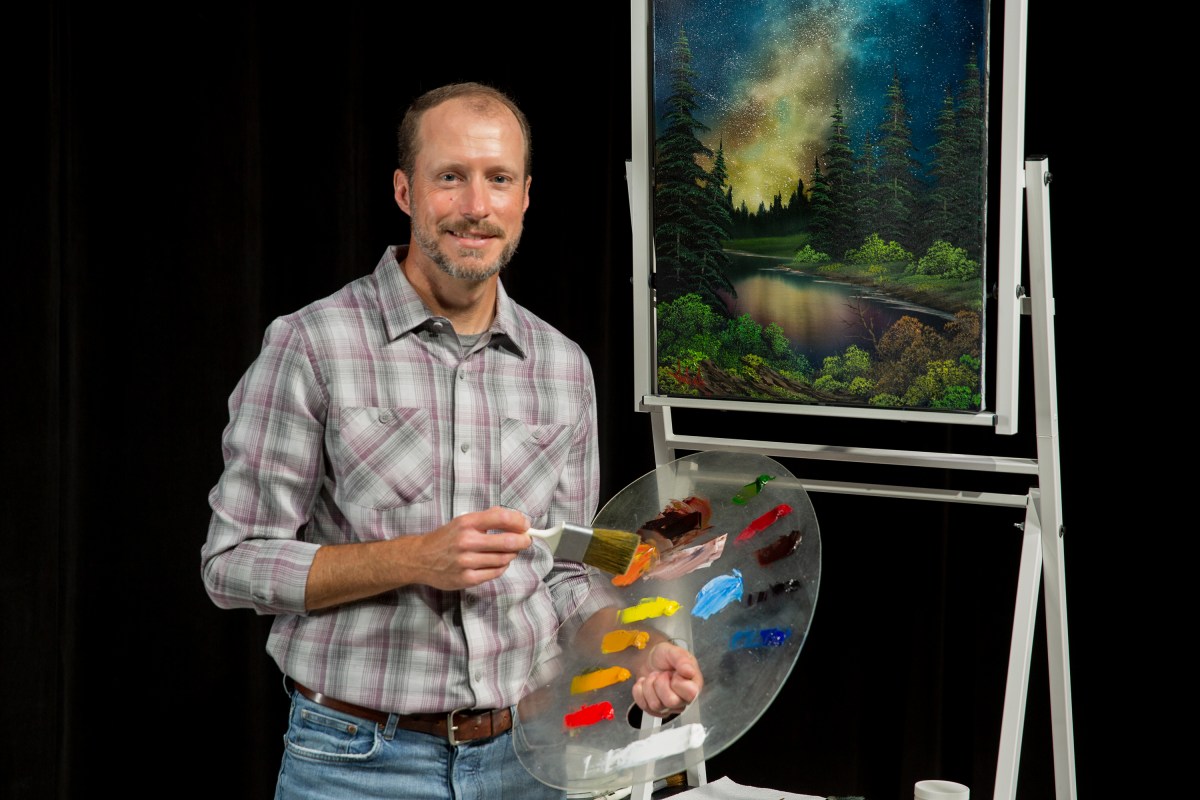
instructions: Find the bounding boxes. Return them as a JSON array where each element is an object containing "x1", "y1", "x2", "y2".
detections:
[{"x1": 626, "y1": 0, "x2": 1076, "y2": 800}]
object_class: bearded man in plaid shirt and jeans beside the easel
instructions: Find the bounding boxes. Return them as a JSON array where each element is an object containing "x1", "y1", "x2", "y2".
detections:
[{"x1": 202, "y1": 84, "x2": 703, "y2": 800}]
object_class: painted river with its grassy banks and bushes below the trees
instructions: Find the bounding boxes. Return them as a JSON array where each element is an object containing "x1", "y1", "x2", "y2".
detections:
[{"x1": 656, "y1": 235, "x2": 983, "y2": 410}]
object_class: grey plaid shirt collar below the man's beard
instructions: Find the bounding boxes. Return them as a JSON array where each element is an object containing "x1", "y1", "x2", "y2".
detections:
[{"x1": 374, "y1": 245, "x2": 528, "y2": 359}]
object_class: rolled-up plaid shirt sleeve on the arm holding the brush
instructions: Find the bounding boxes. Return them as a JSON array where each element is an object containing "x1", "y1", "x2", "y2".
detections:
[{"x1": 200, "y1": 319, "x2": 329, "y2": 614}]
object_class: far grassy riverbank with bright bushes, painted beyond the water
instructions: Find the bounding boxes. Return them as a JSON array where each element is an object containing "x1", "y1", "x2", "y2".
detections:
[{"x1": 725, "y1": 234, "x2": 983, "y2": 315}]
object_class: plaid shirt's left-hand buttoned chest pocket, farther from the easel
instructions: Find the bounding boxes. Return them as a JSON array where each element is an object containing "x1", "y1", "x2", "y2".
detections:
[{"x1": 330, "y1": 407, "x2": 433, "y2": 509}]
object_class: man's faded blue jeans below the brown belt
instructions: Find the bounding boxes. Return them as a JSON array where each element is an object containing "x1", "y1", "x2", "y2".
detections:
[{"x1": 275, "y1": 692, "x2": 566, "y2": 800}]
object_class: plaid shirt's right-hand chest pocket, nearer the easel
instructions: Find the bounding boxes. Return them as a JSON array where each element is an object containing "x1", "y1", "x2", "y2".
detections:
[{"x1": 500, "y1": 419, "x2": 571, "y2": 521}]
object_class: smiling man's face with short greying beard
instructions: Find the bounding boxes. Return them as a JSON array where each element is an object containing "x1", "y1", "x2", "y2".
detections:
[{"x1": 395, "y1": 98, "x2": 530, "y2": 281}]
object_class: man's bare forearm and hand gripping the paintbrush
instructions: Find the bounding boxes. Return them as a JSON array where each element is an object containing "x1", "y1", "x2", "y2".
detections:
[{"x1": 305, "y1": 506, "x2": 533, "y2": 612}]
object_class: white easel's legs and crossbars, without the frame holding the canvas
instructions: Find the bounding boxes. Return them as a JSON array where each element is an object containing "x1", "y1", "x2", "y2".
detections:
[{"x1": 634, "y1": 158, "x2": 1076, "y2": 800}]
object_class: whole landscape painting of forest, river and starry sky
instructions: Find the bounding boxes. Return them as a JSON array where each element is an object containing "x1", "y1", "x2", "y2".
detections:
[{"x1": 650, "y1": 0, "x2": 989, "y2": 413}]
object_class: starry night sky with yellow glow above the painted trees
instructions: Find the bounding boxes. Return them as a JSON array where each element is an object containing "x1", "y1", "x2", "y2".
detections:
[{"x1": 650, "y1": 0, "x2": 988, "y2": 211}]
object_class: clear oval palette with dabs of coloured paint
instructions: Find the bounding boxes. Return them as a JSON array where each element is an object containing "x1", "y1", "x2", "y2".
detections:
[{"x1": 514, "y1": 451, "x2": 821, "y2": 792}]
